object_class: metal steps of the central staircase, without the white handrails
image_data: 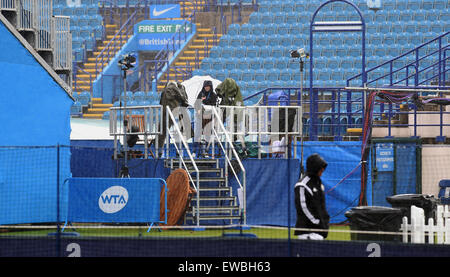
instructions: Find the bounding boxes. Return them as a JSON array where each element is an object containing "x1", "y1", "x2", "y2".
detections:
[{"x1": 165, "y1": 158, "x2": 241, "y2": 224}]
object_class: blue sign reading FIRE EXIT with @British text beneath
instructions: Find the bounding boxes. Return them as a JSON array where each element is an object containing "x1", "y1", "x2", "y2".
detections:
[{"x1": 134, "y1": 20, "x2": 195, "y2": 51}]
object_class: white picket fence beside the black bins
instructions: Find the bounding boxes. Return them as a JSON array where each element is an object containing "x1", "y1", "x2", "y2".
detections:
[{"x1": 400, "y1": 205, "x2": 450, "y2": 244}]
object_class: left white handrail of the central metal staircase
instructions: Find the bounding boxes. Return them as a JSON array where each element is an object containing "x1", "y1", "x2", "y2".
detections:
[{"x1": 166, "y1": 106, "x2": 200, "y2": 226}]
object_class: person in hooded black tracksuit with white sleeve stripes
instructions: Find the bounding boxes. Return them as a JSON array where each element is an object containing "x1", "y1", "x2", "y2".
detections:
[{"x1": 294, "y1": 154, "x2": 330, "y2": 239}]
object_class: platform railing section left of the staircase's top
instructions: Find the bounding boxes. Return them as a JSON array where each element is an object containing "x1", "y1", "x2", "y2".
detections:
[{"x1": 109, "y1": 105, "x2": 163, "y2": 159}]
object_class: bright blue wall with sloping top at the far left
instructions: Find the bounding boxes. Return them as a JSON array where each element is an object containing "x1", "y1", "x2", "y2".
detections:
[{"x1": 0, "y1": 18, "x2": 73, "y2": 224}]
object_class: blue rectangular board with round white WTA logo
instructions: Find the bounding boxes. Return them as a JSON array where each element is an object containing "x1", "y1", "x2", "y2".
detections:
[{"x1": 67, "y1": 178, "x2": 167, "y2": 227}]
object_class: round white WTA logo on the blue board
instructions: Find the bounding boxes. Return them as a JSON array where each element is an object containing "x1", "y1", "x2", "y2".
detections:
[{"x1": 98, "y1": 186, "x2": 128, "y2": 214}]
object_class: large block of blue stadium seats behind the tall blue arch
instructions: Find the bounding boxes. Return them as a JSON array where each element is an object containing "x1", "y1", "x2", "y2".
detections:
[{"x1": 195, "y1": 0, "x2": 450, "y2": 101}]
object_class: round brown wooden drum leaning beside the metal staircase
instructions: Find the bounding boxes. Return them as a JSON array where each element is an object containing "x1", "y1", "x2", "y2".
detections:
[{"x1": 160, "y1": 168, "x2": 196, "y2": 226}]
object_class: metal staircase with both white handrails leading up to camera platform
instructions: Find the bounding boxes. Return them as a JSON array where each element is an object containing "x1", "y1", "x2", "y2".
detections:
[{"x1": 164, "y1": 106, "x2": 246, "y2": 226}]
